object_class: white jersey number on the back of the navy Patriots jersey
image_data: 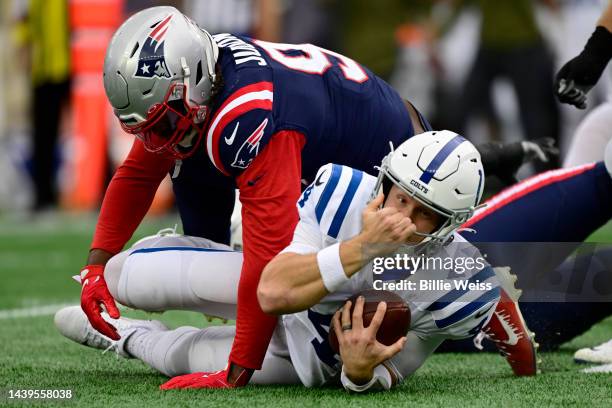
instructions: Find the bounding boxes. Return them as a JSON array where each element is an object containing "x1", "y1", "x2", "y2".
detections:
[{"x1": 255, "y1": 40, "x2": 368, "y2": 83}]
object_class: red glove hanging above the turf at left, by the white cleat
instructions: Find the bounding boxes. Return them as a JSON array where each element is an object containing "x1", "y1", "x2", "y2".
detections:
[{"x1": 81, "y1": 265, "x2": 121, "y2": 340}]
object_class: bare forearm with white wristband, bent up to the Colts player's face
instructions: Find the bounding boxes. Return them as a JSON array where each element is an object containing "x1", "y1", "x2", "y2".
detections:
[{"x1": 257, "y1": 193, "x2": 416, "y2": 314}]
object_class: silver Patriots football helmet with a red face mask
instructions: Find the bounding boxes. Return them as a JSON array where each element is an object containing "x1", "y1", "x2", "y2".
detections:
[{"x1": 104, "y1": 7, "x2": 219, "y2": 158}]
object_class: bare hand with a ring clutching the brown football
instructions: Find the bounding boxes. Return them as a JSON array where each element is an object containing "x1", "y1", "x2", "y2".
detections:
[{"x1": 333, "y1": 296, "x2": 406, "y2": 384}]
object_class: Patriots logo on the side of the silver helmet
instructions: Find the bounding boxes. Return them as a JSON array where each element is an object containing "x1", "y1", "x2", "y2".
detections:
[{"x1": 134, "y1": 15, "x2": 172, "y2": 78}]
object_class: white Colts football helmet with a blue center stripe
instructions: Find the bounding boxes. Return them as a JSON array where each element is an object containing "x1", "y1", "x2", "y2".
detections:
[{"x1": 372, "y1": 130, "x2": 485, "y2": 243}]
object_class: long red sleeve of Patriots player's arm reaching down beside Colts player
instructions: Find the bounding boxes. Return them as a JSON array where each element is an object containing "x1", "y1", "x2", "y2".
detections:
[{"x1": 230, "y1": 131, "x2": 305, "y2": 369}]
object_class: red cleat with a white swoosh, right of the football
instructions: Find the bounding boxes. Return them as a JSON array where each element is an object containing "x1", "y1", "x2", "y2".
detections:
[{"x1": 475, "y1": 268, "x2": 539, "y2": 376}]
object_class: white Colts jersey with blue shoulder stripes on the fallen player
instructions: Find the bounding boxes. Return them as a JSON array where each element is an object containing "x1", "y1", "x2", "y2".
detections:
[{"x1": 282, "y1": 164, "x2": 499, "y2": 386}]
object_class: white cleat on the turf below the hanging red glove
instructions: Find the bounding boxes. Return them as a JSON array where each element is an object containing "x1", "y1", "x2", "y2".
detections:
[{"x1": 54, "y1": 306, "x2": 168, "y2": 358}]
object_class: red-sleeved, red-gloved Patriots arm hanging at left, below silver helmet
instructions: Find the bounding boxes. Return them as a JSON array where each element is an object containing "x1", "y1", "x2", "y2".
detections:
[{"x1": 80, "y1": 140, "x2": 173, "y2": 340}]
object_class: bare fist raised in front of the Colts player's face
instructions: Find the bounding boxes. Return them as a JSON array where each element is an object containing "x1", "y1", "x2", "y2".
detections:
[{"x1": 359, "y1": 192, "x2": 416, "y2": 256}]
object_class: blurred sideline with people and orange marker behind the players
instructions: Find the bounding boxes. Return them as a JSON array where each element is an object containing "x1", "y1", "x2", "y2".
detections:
[{"x1": 0, "y1": 0, "x2": 611, "y2": 222}]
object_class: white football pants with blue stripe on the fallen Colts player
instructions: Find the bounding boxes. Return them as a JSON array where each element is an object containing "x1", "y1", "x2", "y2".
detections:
[{"x1": 104, "y1": 234, "x2": 300, "y2": 384}]
